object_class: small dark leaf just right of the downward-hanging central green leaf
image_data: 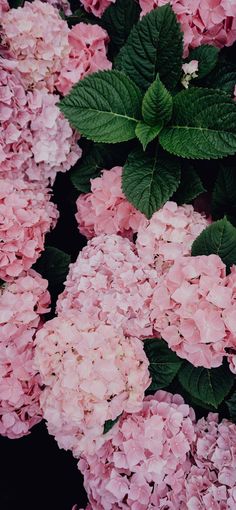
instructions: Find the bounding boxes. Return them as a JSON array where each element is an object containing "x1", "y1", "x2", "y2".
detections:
[{"x1": 173, "y1": 164, "x2": 206, "y2": 205}]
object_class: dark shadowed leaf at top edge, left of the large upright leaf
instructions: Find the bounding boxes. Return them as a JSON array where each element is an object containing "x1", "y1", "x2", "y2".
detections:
[{"x1": 101, "y1": 0, "x2": 141, "y2": 49}]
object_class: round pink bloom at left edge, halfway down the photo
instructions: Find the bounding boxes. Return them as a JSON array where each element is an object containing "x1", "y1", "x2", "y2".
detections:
[{"x1": 0, "y1": 179, "x2": 58, "y2": 281}]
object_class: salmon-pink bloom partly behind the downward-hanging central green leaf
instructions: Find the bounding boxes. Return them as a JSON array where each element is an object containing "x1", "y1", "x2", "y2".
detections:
[{"x1": 76, "y1": 166, "x2": 145, "y2": 239}]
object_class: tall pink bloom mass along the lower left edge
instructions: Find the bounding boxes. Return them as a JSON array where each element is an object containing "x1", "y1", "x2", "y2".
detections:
[{"x1": 0, "y1": 270, "x2": 50, "y2": 439}]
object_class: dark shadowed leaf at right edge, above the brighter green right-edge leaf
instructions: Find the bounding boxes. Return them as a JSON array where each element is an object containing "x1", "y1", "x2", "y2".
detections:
[{"x1": 212, "y1": 167, "x2": 236, "y2": 219}]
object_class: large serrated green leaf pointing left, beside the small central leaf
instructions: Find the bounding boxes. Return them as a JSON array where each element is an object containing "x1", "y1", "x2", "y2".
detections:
[{"x1": 59, "y1": 71, "x2": 142, "y2": 143}]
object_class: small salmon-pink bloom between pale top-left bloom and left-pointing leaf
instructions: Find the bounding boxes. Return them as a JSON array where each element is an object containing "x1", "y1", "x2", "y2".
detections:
[{"x1": 56, "y1": 23, "x2": 112, "y2": 95}]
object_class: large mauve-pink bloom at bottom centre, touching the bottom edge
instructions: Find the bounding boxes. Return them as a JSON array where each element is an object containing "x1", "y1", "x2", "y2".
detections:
[{"x1": 78, "y1": 391, "x2": 195, "y2": 510}]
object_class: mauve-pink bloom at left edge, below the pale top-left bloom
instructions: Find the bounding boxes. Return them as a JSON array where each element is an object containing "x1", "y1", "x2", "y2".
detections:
[{"x1": 0, "y1": 59, "x2": 81, "y2": 184}]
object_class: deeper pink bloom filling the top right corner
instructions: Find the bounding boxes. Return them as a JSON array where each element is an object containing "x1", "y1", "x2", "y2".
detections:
[{"x1": 139, "y1": 0, "x2": 236, "y2": 56}]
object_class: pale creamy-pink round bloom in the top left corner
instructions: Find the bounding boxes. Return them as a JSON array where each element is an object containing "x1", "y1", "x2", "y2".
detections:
[{"x1": 1, "y1": 0, "x2": 70, "y2": 92}]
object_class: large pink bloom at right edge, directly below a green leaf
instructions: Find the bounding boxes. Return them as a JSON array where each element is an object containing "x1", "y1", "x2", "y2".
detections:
[{"x1": 151, "y1": 255, "x2": 236, "y2": 368}]
